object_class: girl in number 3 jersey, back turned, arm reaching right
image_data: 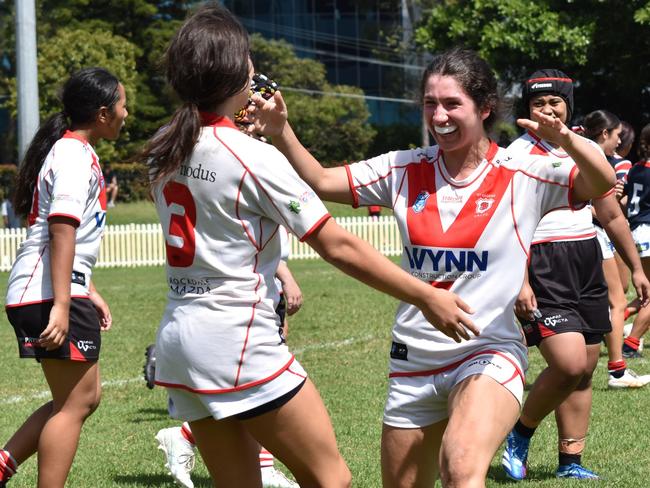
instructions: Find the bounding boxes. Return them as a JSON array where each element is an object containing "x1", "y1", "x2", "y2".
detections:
[{"x1": 141, "y1": 4, "x2": 475, "y2": 487}]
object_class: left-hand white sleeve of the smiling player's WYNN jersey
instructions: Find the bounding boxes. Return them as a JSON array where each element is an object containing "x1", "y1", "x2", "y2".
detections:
[{"x1": 345, "y1": 153, "x2": 395, "y2": 208}]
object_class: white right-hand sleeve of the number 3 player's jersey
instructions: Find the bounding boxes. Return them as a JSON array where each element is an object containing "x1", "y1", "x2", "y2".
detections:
[{"x1": 244, "y1": 143, "x2": 330, "y2": 241}]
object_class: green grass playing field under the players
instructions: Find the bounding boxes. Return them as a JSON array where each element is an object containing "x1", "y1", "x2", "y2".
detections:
[{"x1": 0, "y1": 264, "x2": 650, "y2": 488}]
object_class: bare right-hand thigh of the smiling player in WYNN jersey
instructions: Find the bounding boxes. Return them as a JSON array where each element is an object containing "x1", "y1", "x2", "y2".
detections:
[{"x1": 440, "y1": 375, "x2": 519, "y2": 488}]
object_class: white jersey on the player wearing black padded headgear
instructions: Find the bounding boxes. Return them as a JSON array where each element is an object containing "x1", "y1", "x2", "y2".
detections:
[{"x1": 508, "y1": 132, "x2": 599, "y2": 244}]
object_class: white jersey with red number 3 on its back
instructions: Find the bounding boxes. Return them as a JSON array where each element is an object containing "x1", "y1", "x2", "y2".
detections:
[{"x1": 149, "y1": 117, "x2": 329, "y2": 393}]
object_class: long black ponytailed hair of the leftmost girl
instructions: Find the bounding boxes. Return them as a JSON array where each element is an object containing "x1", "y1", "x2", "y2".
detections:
[{"x1": 14, "y1": 68, "x2": 120, "y2": 216}]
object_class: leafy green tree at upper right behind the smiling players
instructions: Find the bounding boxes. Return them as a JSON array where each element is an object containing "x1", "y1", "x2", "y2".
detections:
[{"x1": 415, "y1": 0, "x2": 650, "y2": 136}]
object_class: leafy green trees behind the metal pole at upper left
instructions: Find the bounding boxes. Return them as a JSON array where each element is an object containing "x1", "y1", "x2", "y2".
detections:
[{"x1": 0, "y1": 0, "x2": 189, "y2": 159}]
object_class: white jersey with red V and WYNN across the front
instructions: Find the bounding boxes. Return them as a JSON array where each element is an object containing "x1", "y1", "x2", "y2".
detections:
[{"x1": 347, "y1": 143, "x2": 575, "y2": 374}]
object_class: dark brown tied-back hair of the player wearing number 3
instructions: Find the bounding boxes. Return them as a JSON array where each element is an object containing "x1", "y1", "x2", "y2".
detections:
[{"x1": 136, "y1": 4, "x2": 249, "y2": 184}]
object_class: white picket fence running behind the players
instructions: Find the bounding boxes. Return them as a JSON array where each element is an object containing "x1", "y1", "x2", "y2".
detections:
[{"x1": 0, "y1": 216, "x2": 402, "y2": 271}]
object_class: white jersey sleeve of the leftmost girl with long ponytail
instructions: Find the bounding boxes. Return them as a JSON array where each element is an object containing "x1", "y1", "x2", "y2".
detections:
[{"x1": 48, "y1": 140, "x2": 92, "y2": 222}]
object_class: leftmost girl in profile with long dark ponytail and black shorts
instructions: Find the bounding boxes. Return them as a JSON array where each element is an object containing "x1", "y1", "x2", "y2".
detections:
[{"x1": 0, "y1": 68, "x2": 128, "y2": 488}]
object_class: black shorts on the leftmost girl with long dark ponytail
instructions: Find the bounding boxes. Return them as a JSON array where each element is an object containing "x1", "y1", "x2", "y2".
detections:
[{"x1": 6, "y1": 298, "x2": 101, "y2": 361}]
